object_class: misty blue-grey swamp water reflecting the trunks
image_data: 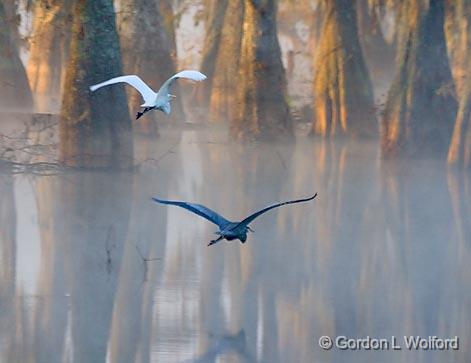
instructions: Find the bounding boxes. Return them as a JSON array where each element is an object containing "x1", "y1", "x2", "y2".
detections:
[{"x1": 0, "y1": 123, "x2": 471, "y2": 363}]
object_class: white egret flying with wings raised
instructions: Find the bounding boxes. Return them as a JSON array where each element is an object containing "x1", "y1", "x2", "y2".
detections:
[{"x1": 90, "y1": 70, "x2": 206, "y2": 120}]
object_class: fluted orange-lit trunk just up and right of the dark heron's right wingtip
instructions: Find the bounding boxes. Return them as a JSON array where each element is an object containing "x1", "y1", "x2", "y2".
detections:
[{"x1": 312, "y1": 0, "x2": 377, "y2": 137}]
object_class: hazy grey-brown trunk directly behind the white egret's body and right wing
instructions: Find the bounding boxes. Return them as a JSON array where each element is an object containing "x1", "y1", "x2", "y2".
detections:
[{"x1": 117, "y1": 0, "x2": 183, "y2": 133}]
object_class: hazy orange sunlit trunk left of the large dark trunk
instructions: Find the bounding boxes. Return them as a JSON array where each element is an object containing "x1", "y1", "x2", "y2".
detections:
[{"x1": 26, "y1": 0, "x2": 72, "y2": 112}]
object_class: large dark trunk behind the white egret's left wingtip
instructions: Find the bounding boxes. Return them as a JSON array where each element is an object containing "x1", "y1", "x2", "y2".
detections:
[{"x1": 59, "y1": 0, "x2": 133, "y2": 168}]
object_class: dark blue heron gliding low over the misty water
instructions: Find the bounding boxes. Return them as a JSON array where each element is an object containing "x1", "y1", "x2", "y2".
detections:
[{"x1": 152, "y1": 193, "x2": 317, "y2": 246}]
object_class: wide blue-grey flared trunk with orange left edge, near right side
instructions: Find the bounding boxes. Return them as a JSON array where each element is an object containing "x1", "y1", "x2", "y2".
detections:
[{"x1": 381, "y1": 0, "x2": 457, "y2": 158}]
